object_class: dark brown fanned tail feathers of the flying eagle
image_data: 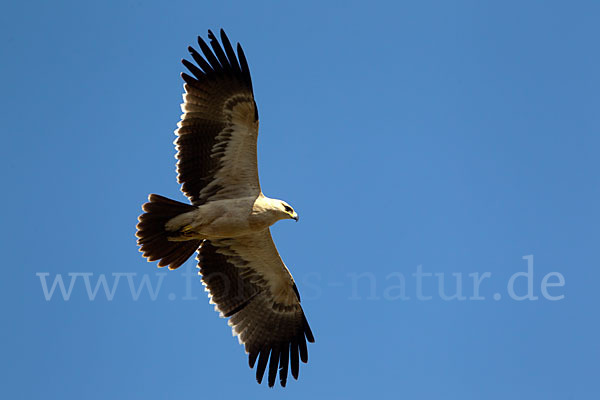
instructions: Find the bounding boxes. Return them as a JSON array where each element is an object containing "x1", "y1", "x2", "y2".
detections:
[{"x1": 135, "y1": 194, "x2": 202, "y2": 269}]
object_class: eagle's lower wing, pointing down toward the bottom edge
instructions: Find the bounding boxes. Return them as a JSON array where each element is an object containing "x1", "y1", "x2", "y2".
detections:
[{"x1": 198, "y1": 229, "x2": 315, "y2": 386}]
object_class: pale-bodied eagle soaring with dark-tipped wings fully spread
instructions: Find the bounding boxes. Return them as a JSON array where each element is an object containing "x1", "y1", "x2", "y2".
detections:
[{"x1": 136, "y1": 29, "x2": 314, "y2": 387}]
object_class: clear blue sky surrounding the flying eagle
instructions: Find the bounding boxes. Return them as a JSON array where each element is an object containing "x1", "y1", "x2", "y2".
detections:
[{"x1": 0, "y1": 1, "x2": 600, "y2": 400}]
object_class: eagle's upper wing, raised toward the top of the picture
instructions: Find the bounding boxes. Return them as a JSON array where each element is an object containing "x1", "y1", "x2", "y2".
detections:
[{"x1": 175, "y1": 29, "x2": 260, "y2": 206}]
